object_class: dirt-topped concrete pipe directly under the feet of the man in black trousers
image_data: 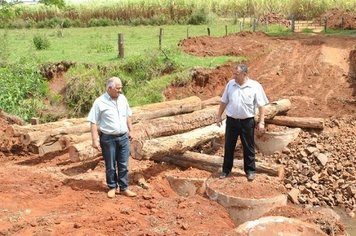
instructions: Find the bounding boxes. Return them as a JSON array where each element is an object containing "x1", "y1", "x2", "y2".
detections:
[{"x1": 206, "y1": 174, "x2": 287, "y2": 226}]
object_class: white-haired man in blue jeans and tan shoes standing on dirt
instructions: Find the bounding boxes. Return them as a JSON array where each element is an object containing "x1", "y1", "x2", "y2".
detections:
[{"x1": 88, "y1": 77, "x2": 136, "y2": 198}]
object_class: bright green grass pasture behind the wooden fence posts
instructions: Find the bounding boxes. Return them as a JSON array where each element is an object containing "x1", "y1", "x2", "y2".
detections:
[{"x1": 0, "y1": 25, "x2": 243, "y2": 64}]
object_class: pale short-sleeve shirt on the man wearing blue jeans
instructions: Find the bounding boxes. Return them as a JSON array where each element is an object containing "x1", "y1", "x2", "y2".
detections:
[{"x1": 88, "y1": 92, "x2": 132, "y2": 135}]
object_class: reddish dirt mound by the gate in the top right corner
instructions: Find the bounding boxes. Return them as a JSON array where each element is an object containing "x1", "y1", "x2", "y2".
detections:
[{"x1": 314, "y1": 9, "x2": 356, "y2": 30}]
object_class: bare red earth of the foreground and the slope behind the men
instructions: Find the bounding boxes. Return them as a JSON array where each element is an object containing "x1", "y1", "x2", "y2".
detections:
[{"x1": 0, "y1": 33, "x2": 356, "y2": 235}]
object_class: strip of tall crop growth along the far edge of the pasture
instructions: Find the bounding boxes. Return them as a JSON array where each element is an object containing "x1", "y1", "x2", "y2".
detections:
[{"x1": 0, "y1": 0, "x2": 356, "y2": 28}]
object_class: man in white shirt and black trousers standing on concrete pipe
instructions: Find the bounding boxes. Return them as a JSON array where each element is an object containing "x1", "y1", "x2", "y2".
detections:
[{"x1": 216, "y1": 64, "x2": 268, "y2": 181}]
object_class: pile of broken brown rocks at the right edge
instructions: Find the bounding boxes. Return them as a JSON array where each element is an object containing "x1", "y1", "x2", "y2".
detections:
[{"x1": 267, "y1": 117, "x2": 356, "y2": 215}]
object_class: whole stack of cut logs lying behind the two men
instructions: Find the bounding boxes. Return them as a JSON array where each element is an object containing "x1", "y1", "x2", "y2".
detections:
[{"x1": 2, "y1": 96, "x2": 323, "y2": 175}]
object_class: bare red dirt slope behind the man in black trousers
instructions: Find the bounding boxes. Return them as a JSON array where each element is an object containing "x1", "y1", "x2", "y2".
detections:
[{"x1": 168, "y1": 32, "x2": 356, "y2": 117}]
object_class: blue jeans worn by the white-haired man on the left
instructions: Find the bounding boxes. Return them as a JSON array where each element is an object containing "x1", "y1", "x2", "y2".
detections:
[{"x1": 100, "y1": 133, "x2": 130, "y2": 190}]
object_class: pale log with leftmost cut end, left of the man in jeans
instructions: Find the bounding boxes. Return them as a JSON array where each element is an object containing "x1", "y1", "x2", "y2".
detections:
[{"x1": 20, "y1": 122, "x2": 90, "y2": 147}]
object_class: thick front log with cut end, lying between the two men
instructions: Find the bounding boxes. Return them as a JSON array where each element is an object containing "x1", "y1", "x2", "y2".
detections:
[{"x1": 131, "y1": 122, "x2": 225, "y2": 160}]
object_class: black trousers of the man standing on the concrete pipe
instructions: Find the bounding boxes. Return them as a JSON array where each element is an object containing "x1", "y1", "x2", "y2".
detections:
[{"x1": 222, "y1": 117, "x2": 256, "y2": 174}]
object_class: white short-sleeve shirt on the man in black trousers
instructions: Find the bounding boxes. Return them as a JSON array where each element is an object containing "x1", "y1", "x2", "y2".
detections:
[{"x1": 221, "y1": 79, "x2": 268, "y2": 119}]
